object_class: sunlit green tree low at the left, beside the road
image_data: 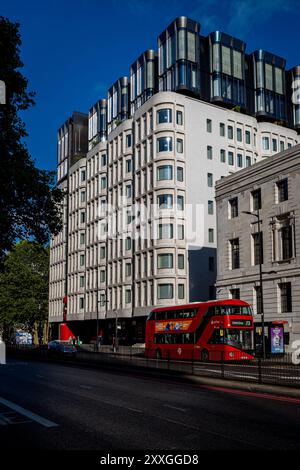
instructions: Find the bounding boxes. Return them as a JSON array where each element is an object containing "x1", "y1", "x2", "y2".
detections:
[{"x1": 0, "y1": 240, "x2": 49, "y2": 339}]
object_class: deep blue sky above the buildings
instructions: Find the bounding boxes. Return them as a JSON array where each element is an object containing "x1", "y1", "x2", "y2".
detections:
[{"x1": 0, "y1": 0, "x2": 300, "y2": 173}]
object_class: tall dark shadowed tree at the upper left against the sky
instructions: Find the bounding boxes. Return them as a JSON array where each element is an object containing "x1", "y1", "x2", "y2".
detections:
[{"x1": 0, "y1": 16, "x2": 63, "y2": 263}]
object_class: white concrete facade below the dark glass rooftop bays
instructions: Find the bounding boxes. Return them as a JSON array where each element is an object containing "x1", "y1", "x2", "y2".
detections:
[{"x1": 49, "y1": 92, "x2": 298, "y2": 322}]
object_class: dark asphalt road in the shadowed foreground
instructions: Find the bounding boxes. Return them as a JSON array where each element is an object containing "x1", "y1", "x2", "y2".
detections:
[{"x1": 0, "y1": 359, "x2": 300, "y2": 451}]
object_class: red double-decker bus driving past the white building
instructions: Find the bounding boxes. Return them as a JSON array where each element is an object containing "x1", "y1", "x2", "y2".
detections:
[{"x1": 146, "y1": 299, "x2": 254, "y2": 361}]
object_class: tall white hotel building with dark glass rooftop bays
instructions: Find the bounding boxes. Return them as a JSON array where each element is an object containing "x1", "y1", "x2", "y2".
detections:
[{"x1": 49, "y1": 17, "x2": 300, "y2": 342}]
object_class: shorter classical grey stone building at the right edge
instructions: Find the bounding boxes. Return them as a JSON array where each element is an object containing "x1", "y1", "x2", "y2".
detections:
[{"x1": 216, "y1": 145, "x2": 300, "y2": 344}]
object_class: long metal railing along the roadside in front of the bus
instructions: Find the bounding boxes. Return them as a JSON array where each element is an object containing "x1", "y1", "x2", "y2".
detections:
[{"x1": 7, "y1": 345, "x2": 300, "y2": 388}]
